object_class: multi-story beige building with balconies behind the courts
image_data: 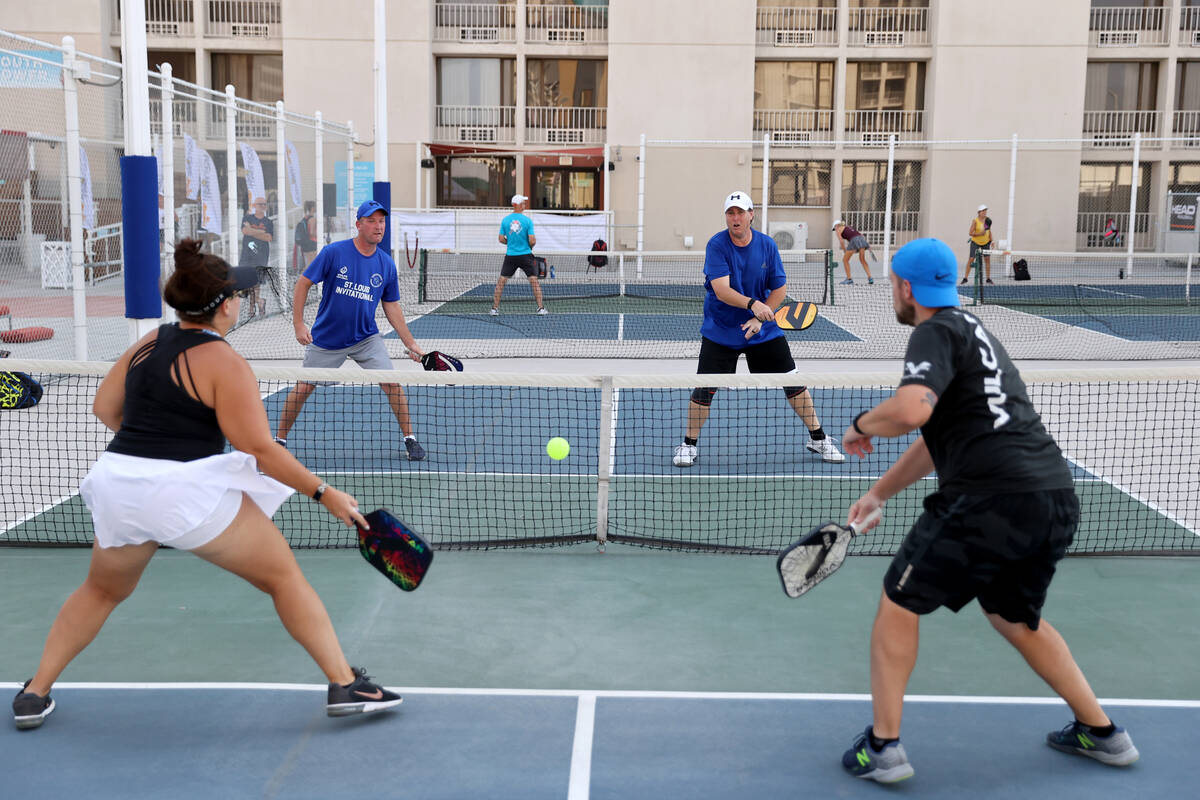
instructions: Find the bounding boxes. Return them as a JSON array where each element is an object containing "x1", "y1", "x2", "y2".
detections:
[{"x1": 4, "y1": 0, "x2": 1200, "y2": 252}]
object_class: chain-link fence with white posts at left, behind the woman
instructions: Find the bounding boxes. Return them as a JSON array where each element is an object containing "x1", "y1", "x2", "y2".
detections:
[{"x1": 0, "y1": 31, "x2": 361, "y2": 360}]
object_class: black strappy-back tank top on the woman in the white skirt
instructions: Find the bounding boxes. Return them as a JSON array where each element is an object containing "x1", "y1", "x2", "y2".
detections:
[{"x1": 108, "y1": 324, "x2": 226, "y2": 461}]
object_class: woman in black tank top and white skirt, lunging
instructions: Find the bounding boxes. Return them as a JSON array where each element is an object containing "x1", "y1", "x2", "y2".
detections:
[{"x1": 13, "y1": 240, "x2": 401, "y2": 728}]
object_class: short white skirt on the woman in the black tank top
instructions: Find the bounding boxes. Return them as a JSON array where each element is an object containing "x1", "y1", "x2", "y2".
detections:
[{"x1": 79, "y1": 450, "x2": 293, "y2": 549}]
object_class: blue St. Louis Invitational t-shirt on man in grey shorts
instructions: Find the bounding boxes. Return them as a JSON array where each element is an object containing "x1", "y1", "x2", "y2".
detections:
[{"x1": 304, "y1": 239, "x2": 400, "y2": 350}]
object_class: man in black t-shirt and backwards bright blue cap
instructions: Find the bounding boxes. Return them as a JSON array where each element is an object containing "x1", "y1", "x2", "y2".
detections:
[{"x1": 842, "y1": 239, "x2": 1138, "y2": 783}]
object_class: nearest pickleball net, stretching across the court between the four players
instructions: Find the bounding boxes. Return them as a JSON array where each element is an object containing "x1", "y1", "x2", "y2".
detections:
[{"x1": 0, "y1": 360, "x2": 1200, "y2": 554}]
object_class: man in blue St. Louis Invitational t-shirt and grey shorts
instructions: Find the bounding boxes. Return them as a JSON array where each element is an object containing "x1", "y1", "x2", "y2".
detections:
[{"x1": 275, "y1": 200, "x2": 425, "y2": 461}]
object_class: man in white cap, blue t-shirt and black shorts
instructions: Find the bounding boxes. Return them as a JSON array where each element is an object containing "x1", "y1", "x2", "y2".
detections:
[{"x1": 673, "y1": 192, "x2": 846, "y2": 467}]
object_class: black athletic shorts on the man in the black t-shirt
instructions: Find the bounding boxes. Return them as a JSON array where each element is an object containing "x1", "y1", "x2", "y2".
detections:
[{"x1": 883, "y1": 488, "x2": 1079, "y2": 630}]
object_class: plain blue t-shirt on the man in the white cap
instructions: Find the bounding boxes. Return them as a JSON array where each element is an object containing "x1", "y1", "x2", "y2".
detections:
[{"x1": 700, "y1": 230, "x2": 787, "y2": 349}]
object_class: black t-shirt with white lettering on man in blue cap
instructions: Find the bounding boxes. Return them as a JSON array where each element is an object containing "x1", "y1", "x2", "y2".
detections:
[{"x1": 900, "y1": 308, "x2": 1074, "y2": 494}]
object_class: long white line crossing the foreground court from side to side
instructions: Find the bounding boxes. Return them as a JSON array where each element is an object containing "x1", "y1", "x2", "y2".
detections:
[{"x1": 9, "y1": 681, "x2": 1200, "y2": 709}]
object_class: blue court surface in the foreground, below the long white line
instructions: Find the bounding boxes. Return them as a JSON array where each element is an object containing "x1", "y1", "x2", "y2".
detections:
[{"x1": 0, "y1": 684, "x2": 1200, "y2": 800}]
